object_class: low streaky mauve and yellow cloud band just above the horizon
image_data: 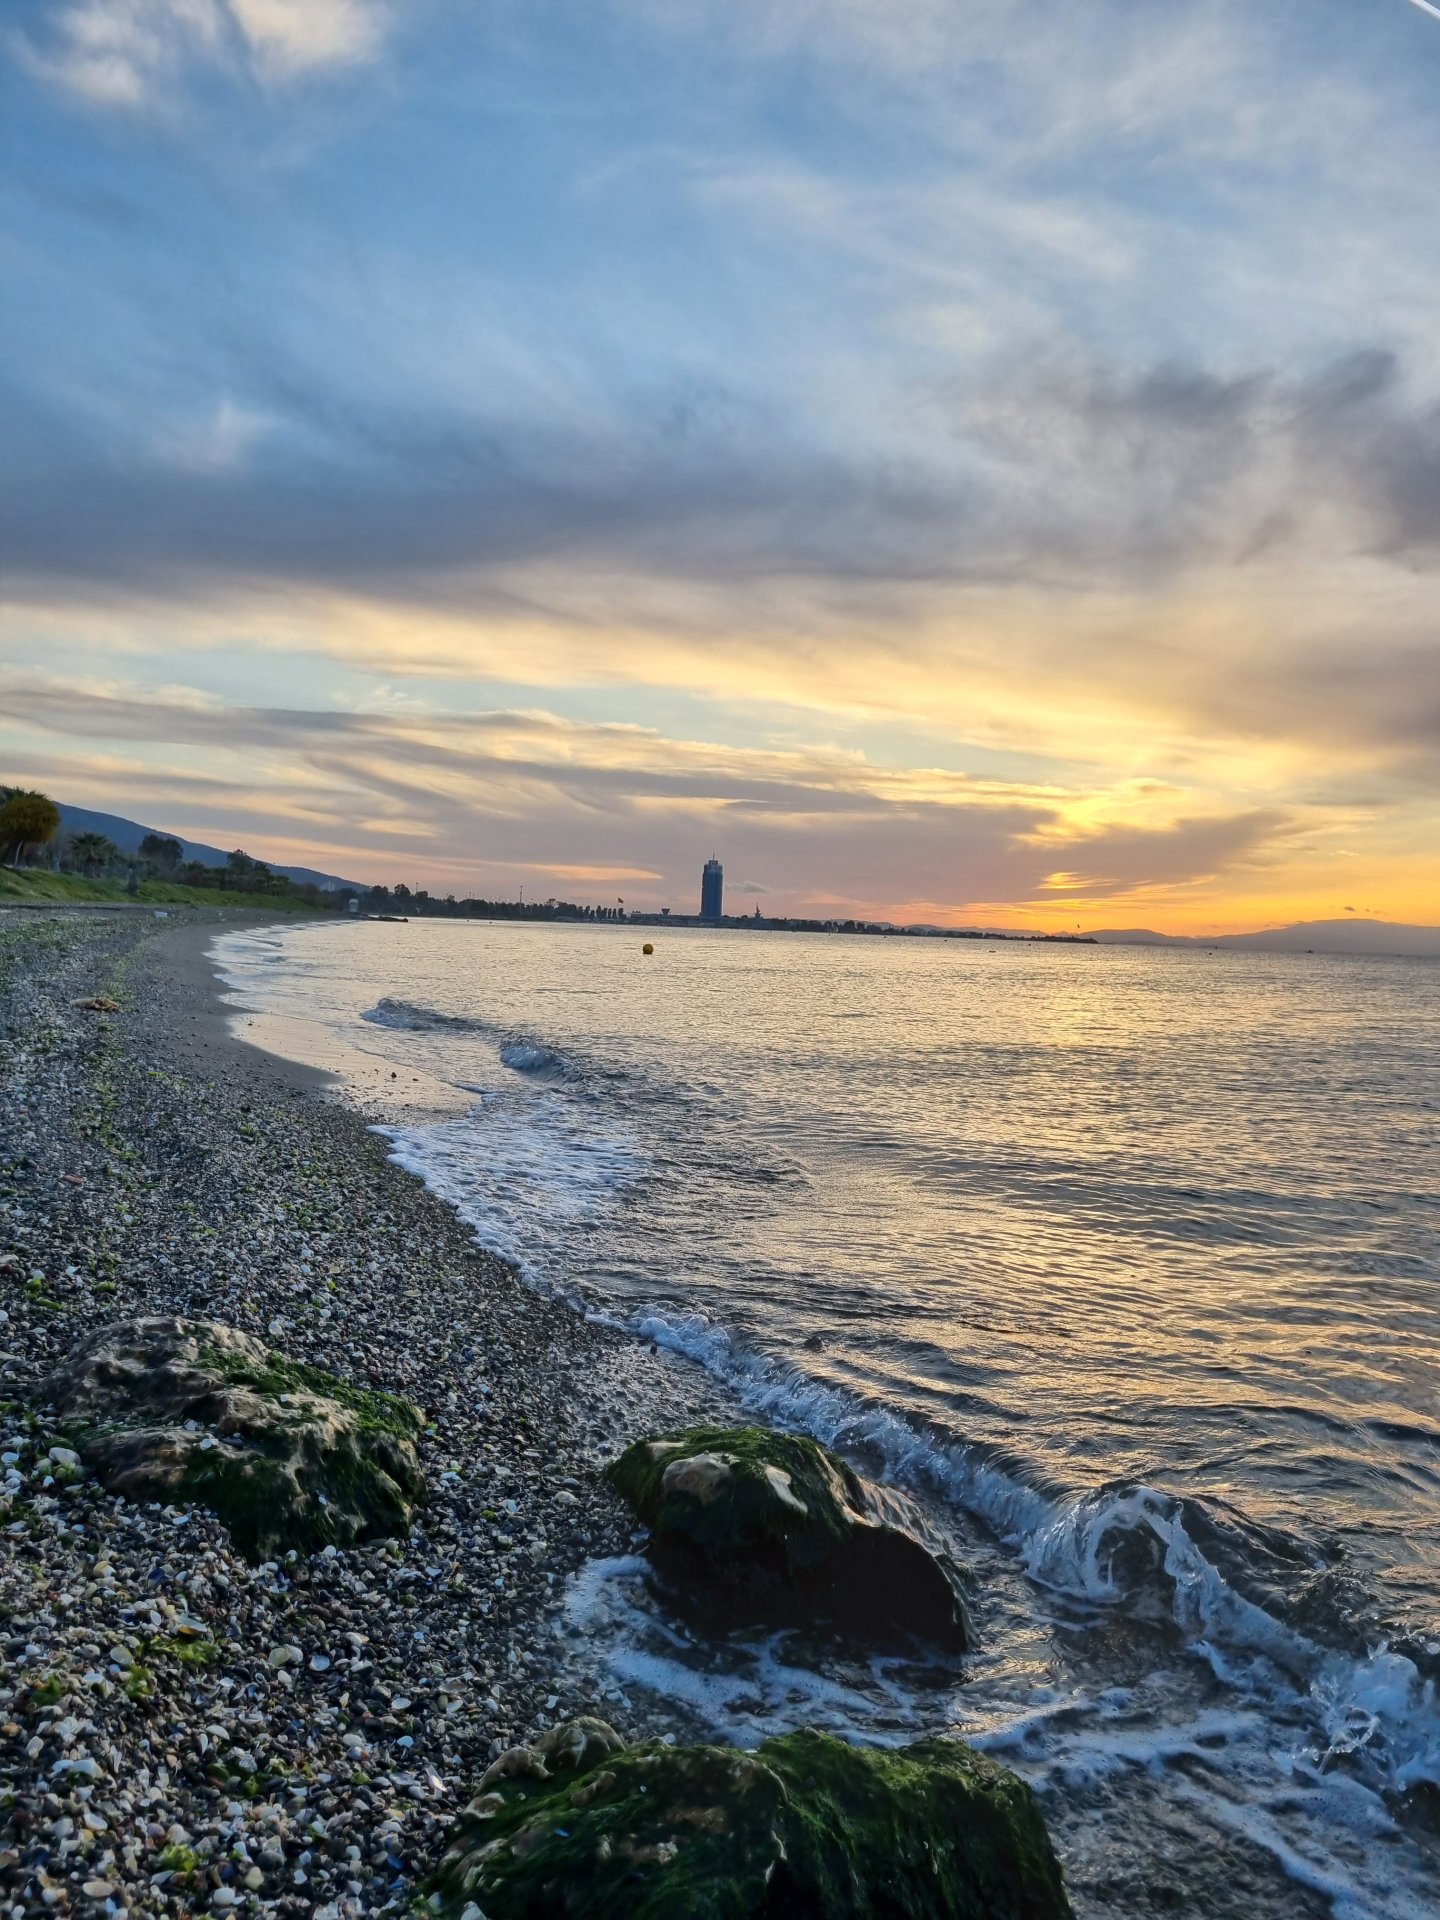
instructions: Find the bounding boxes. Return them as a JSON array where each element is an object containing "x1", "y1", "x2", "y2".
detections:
[{"x1": 4, "y1": 678, "x2": 1300, "y2": 918}]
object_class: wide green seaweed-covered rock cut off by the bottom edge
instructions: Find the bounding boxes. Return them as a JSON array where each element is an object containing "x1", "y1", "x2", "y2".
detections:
[{"x1": 432, "y1": 1720, "x2": 1069, "y2": 1920}]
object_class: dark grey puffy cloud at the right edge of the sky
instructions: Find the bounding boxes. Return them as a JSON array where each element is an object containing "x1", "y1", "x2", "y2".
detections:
[{"x1": 947, "y1": 346, "x2": 1440, "y2": 580}]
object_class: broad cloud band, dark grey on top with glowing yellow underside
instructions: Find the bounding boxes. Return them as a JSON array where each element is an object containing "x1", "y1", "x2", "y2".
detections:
[{"x1": 0, "y1": 318, "x2": 1440, "y2": 806}]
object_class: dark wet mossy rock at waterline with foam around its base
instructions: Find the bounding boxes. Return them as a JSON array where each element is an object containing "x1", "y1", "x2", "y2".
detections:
[{"x1": 607, "y1": 1427, "x2": 970, "y2": 1651}]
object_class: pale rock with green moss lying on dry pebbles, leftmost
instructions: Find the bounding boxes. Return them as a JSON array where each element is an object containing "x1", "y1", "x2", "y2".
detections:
[{"x1": 40, "y1": 1319, "x2": 424, "y2": 1559}]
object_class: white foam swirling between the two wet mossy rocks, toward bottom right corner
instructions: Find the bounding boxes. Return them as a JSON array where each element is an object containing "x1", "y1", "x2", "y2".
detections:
[{"x1": 563, "y1": 1555, "x2": 1436, "y2": 1920}]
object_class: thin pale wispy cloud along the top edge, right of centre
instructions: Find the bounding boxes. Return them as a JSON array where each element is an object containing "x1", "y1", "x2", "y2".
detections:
[{"x1": 616, "y1": 0, "x2": 1428, "y2": 175}]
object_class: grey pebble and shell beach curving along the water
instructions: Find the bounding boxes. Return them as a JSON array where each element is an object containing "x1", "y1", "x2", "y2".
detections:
[{"x1": 0, "y1": 908, "x2": 722, "y2": 1920}]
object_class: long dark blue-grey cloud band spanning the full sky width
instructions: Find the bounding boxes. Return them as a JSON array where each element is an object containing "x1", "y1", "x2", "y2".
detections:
[{"x1": 0, "y1": 317, "x2": 1440, "y2": 609}]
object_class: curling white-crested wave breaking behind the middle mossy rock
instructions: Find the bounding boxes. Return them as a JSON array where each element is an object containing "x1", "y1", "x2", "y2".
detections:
[{"x1": 610, "y1": 1311, "x2": 1440, "y2": 1791}]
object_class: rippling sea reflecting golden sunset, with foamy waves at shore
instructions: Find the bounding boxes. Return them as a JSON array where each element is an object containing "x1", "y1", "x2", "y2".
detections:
[{"x1": 217, "y1": 920, "x2": 1440, "y2": 1920}]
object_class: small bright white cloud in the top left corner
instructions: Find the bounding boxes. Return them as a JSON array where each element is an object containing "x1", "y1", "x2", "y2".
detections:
[{"x1": 19, "y1": 0, "x2": 388, "y2": 109}]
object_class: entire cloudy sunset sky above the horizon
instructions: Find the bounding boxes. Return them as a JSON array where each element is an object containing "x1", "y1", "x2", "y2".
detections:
[{"x1": 0, "y1": 0, "x2": 1440, "y2": 933}]
